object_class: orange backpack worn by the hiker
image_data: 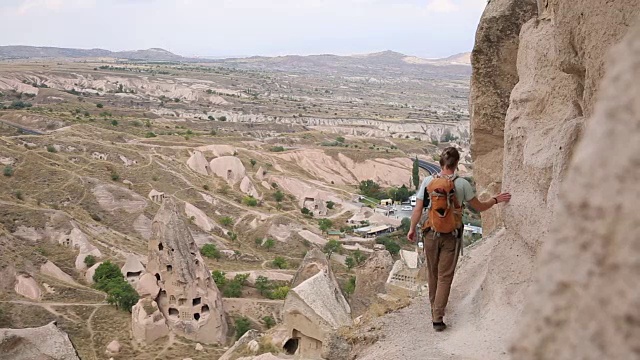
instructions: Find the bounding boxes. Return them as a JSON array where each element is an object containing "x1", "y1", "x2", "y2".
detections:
[{"x1": 422, "y1": 174, "x2": 462, "y2": 234}]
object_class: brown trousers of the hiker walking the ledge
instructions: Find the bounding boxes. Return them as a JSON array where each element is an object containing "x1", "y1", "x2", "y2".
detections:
[{"x1": 423, "y1": 232, "x2": 462, "y2": 322}]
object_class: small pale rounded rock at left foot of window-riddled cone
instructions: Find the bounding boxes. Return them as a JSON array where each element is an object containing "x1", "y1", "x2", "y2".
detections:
[{"x1": 131, "y1": 299, "x2": 169, "y2": 344}]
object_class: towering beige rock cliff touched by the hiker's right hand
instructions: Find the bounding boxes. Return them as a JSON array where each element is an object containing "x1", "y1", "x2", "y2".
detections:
[{"x1": 464, "y1": 0, "x2": 640, "y2": 359}]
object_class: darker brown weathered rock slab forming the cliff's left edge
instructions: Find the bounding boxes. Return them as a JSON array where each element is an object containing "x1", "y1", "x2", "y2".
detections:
[{"x1": 469, "y1": 0, "x2": 536, "y2": 234}]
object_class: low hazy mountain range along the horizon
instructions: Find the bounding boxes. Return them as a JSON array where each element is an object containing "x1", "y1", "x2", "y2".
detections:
[{"x1": 0, "y1": 45, "x2": 471, "y2": 67}]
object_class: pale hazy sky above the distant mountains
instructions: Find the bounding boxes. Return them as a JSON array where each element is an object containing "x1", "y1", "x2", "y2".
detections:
[{"x1": 0, "y1": 0, "x2": 487, "y2": 57}]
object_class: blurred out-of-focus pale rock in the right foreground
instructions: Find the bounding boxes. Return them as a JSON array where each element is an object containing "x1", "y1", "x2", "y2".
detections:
[{"x1": 512, "y1": 16, "x2": 640, "y2": 360}]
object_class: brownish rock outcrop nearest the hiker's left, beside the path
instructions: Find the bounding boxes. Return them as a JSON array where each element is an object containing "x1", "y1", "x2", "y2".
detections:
[{"x1": 351, "y1": 250, "x2": 393, "y2": 317}]
